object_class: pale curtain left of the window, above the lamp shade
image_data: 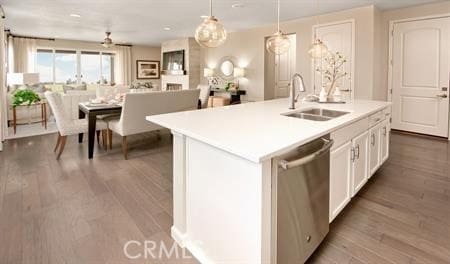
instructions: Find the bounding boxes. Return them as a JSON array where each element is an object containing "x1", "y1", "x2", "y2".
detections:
[{"x1": 9, "y1": 37, "x2": 36, "y2": 73}]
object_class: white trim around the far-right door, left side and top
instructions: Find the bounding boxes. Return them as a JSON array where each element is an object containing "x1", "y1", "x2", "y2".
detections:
[{"x1": 387, "y1": 13, "x2": 450, "y2": 141}]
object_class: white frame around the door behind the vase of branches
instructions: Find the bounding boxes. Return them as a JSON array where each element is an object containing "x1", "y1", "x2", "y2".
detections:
[{"x1": 311, "y1": 18, "x2": 356, "y2": 101}]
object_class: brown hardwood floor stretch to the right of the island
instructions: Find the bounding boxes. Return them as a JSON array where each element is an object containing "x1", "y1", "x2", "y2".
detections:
[{"x1": 309, "y1": 132, "x2": 450, "y2": 264}]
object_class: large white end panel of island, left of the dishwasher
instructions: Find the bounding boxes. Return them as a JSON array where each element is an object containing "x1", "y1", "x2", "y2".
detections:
[{"x1": 185, "y1": 137, "x2": 271, "y2": 263}]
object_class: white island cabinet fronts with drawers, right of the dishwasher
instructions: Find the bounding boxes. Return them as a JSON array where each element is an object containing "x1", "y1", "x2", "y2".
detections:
[{"x1": 329, "y1": 108, "x2": 390, "y2": 222}]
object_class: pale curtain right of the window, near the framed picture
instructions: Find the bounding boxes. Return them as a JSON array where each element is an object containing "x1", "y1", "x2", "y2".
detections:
[{"x1": 114, "y1": 46, "x2": 132, "y2": 85}]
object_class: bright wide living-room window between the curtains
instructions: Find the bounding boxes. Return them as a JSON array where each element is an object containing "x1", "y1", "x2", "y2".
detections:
[{"x1": 36, "y1": 49, "x2": 114, "y2": 88}]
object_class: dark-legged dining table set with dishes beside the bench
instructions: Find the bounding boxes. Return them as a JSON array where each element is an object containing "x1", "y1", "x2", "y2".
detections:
[{"x1": 78, "y1": 93, "x2": 125, "y2": 159}]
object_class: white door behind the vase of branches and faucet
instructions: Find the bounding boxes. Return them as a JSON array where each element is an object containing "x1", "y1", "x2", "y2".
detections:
[{"x1": 312, "y1": 21, "x2": 354, "y2": 101}]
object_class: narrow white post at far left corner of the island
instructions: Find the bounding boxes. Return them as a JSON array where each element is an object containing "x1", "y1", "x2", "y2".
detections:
[{"x1": 171, "y1": 131, "x2": 186, "y2": 247}]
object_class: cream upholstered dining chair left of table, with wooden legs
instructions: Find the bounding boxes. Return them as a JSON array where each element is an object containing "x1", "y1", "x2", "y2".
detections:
[{"x1": 45, "y1": 91, "x2": 107, "y2": 160}]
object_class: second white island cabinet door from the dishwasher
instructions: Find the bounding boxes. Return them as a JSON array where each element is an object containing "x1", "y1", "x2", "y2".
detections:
[{"x1": 352, "y1": 132, "x2": 369, "y2": 196}]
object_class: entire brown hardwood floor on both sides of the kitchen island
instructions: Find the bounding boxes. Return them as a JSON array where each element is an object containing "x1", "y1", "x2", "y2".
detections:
[{"x1": 0, "y1": 133, "x2": 450, "y2": 264}]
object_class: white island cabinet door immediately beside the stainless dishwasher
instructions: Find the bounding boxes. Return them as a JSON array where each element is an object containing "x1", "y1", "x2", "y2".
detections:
[{"x1": 330, "y1": 141, "x2": 353, "y2": 222}]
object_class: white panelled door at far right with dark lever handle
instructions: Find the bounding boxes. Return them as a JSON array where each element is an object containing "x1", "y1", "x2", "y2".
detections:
[{"x1": 391, "y1": 17, "x2": 450, "y2": 137}]
